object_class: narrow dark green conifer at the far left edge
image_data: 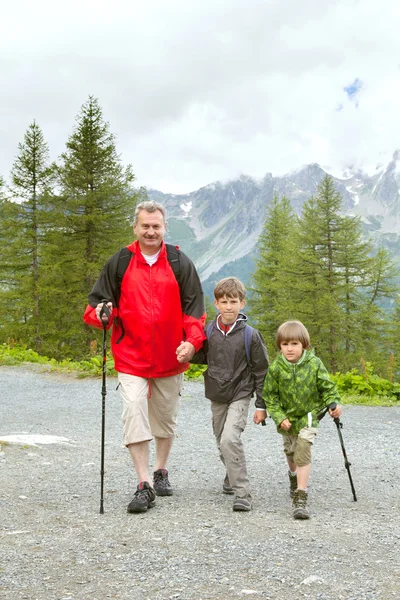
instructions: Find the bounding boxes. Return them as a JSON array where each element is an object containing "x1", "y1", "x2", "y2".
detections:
[{"x1": 0, "y1": 121, "x2": 53, "y2": 351}]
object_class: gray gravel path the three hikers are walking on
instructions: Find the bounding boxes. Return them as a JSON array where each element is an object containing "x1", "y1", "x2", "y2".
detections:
[{"x1": 0, "y1": 367, "x2": 400, "y2": 600}]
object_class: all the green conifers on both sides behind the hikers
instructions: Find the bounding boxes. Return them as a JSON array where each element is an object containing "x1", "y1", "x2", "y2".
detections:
[{"x1": 0, "y1": 96, "x2": 400, "y2": 381}]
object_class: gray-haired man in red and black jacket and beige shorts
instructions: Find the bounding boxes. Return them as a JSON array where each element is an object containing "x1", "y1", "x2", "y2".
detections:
[{"x1": 84, "y1": 202, "x2": 206, "y2": 513}]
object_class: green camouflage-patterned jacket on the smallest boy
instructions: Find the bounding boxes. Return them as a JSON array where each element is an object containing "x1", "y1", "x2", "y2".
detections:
[{"x1": 263, "y1": 350, "x2": 340, "y2": 435}]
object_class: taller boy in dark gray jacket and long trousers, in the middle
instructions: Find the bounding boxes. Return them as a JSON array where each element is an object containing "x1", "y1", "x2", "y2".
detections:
[{"x1": 177, "y1": 277, "x2": 268, "y2": 511}]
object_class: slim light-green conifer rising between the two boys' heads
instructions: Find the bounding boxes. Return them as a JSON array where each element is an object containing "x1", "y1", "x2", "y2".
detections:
[{"x1": 249, "y1": 194, "x2": 297, "y2": 354}]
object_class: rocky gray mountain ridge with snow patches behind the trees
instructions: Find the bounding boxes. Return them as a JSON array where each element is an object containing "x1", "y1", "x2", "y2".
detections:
[{"x1": 148, "y1": 151, "x2": 400, "y2": 295}]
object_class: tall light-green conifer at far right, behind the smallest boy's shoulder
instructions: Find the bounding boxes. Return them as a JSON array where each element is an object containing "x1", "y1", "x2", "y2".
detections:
[{"x1": 295, "y1": 176, "x2": 395, "y2": 372}]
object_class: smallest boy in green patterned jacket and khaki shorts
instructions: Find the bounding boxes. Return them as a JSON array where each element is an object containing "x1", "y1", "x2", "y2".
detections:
[{"x1": 263, "y1": 321, "x2": 342, "y2": 519}]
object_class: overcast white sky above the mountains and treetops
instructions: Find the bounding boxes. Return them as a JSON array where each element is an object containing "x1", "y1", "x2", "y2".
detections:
[{"x1": 0, "y1": 0, "x2": 400, "y2": 193}]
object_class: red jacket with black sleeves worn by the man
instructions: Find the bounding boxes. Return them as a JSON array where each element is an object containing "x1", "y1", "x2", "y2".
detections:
[{"x1": 83, "y1": 242, "x2": 206, "y2": 379}]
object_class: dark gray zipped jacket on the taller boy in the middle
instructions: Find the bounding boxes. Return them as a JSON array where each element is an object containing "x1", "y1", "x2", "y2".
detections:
[{"x1": 190, "y1": 313, "x2": 268, "y2": 410}]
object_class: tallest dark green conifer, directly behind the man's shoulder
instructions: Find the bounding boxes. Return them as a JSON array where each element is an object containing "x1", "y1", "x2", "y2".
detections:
[{"x1": 45, "y1": 96, "x2": 144, "y2": 356}]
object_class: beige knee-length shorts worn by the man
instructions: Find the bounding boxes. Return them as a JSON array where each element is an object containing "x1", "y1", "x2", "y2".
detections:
[{"x1": 118, "y1": 373, "x2": 183, "y2": 446}]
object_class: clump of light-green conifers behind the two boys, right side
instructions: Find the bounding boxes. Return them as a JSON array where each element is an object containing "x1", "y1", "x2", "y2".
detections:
[{"x1": 250, "y1": 176, "x2": 400, "y2": 375}]
